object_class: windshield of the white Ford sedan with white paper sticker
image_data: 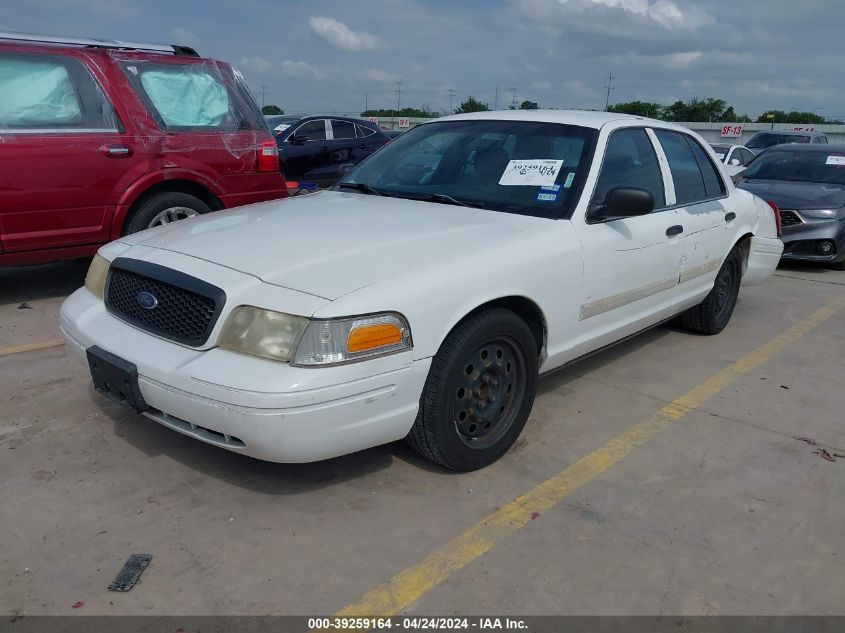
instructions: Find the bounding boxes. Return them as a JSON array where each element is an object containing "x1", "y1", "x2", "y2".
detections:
[{"x1": 336, "y1": 121, "x2": 597, "y2": 218}]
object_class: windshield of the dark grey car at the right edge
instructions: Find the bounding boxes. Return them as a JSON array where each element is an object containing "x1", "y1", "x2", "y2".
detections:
[{"x1": 743, "y1": 150, "x2": 845, "y2": 185}]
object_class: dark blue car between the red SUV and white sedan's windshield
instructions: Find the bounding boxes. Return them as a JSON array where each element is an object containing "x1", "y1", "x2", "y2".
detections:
[{"x1": 265, "y1": 115, "x2": 390, "y2": 187}]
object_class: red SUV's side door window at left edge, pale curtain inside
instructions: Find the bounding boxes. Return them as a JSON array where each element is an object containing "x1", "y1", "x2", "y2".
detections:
[{"x1": 0, "y1": 54, "x2": 119, "y2": 132}]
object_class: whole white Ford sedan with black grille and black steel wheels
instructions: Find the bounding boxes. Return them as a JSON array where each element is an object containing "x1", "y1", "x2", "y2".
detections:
[{"x1": 61, "y1": 111, "x2": 783, "y2": 470}]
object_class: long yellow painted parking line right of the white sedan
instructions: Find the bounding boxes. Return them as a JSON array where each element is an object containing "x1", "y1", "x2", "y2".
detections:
[{"x1": 337, "y1": 297, "x2": 845, "y2": 617}]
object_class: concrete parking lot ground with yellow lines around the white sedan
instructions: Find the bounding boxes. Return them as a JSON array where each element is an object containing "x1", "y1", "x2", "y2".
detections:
[{"x1": 0, "y1": 262, "x2": 845, "y2": 615}]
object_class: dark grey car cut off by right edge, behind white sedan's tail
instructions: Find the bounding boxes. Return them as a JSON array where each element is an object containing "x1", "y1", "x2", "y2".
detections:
[{"x1": 737, "y1": 145, "x2": 845, "y2": 270}]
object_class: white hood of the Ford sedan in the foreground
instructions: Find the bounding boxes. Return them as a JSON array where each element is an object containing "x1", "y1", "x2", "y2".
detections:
[{"x1": 126, "y1": 191, "x2": 549, "y2": 300}]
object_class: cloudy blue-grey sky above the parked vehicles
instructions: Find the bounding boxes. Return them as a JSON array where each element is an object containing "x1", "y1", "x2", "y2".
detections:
[{"x1": 6, "y1": 0, "x2": 845, "y2": 119}]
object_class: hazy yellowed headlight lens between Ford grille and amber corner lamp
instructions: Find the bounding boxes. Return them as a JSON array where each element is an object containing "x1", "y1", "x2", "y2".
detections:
[{"x1": 217, "y1": 306, "x2": 308, "y2": 361}]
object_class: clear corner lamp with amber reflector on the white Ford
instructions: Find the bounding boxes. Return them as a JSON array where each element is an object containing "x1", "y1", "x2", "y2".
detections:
[{"x1": 292, "y1": 312, "x2": 411, "y2": 367}]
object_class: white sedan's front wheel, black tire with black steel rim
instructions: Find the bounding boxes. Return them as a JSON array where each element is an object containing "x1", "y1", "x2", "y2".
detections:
[{"x1": 406, "y1": 308, "x2": 538, "y2": 471}]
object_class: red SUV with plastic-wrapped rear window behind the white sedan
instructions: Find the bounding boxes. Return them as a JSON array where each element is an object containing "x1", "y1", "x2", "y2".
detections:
[{"x1": 0, "y1": 33, "x2": 287, "y2": 265}]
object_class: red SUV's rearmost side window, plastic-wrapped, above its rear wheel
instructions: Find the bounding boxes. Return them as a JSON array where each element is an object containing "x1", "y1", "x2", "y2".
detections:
[{"x1": 124, "y1": 62, "x2": 252, "y2": 130}]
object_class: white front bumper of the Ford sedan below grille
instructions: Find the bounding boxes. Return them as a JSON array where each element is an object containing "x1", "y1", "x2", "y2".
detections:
[{"x1": 60, "y1": 288, "x2": 430, "y2": 462}]
